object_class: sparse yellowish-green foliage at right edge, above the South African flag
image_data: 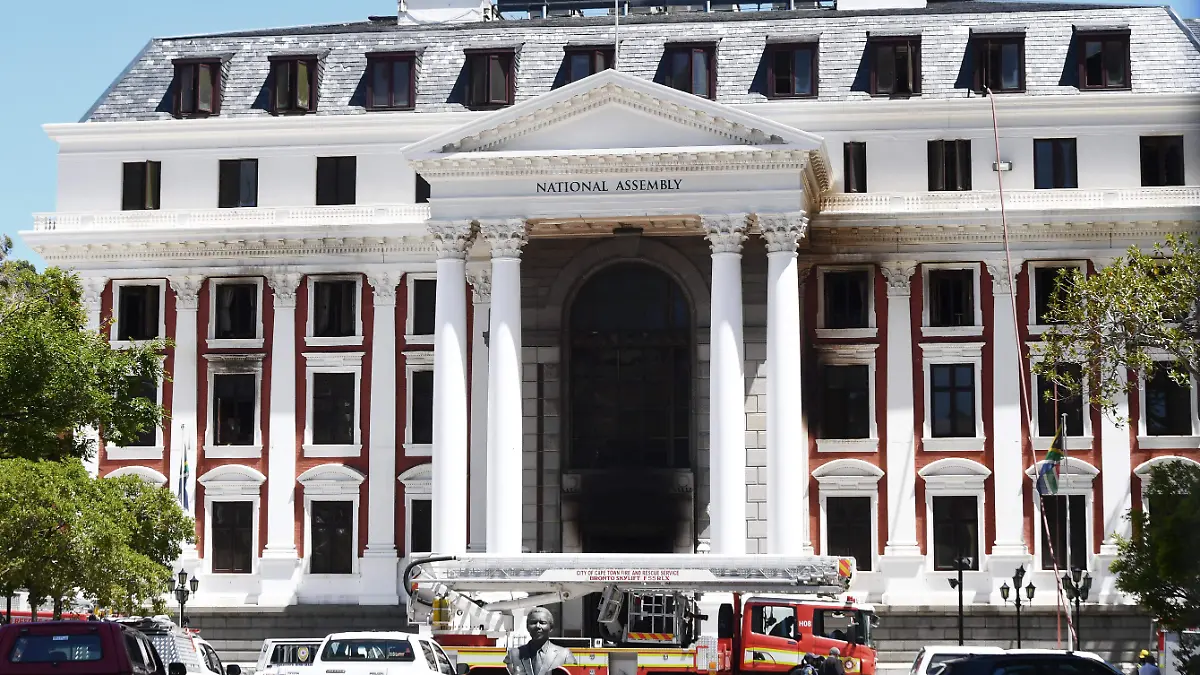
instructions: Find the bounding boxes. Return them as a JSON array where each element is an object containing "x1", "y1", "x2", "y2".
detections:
[{"x1": 1033, "y1": 235, "x2": 1200, "y2": 413}]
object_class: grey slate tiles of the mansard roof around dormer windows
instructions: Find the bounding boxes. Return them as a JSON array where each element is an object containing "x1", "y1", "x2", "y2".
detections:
[{"x1": 84, "y1": 0, "x2": 1200, "y2": 124}]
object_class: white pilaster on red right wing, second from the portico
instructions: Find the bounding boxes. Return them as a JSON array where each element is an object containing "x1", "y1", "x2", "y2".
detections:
[{"x1": 986, "y1": 258, "x2": 1032, "y2": 557}]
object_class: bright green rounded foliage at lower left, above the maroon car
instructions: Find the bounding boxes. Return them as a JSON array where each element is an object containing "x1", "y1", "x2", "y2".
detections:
[{"x1": 0, "y1": 459, "x2": 194, "y2": 611}]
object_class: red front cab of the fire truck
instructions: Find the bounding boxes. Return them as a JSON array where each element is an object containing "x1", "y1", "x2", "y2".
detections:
[{"x1": 738, "y1": 596, "x2": 877, "y2": 675}]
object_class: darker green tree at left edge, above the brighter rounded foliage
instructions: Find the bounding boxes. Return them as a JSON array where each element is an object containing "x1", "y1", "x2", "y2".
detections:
[{"x1": 0, "y1": 239, "x2": 164, "y2": 459}]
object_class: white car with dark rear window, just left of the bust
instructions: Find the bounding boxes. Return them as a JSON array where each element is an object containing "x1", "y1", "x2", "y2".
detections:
[{"x1": 312, "y1": 631, "x2": 457, "y2": 675}]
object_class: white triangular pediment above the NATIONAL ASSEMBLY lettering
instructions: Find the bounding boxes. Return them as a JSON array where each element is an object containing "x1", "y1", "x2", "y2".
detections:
[{"x1": 404, "y1": 70, "x2": 823, "y2": 161}]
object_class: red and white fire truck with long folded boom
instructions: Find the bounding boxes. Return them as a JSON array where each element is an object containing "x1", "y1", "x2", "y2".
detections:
[{"x1": 404, "y1": 554, "x2": 877, "y2": 675}]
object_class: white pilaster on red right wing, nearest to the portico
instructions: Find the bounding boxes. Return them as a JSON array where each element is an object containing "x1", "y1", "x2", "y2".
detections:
[{"x1": 880, "y1": 261, "x2": 920, "y2": 558}]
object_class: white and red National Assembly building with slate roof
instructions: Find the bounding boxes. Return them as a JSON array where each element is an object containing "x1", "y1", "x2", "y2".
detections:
[{"x1": 23, "y1": 0, "x2": 1200, "y2": 627}]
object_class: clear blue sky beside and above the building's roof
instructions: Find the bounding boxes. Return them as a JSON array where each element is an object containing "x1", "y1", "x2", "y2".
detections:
[{"x1": 0, "y1": 0, "x2": 1200, "y2": 264}]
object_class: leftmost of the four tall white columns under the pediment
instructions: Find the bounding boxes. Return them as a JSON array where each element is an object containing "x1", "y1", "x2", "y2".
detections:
[{"x1": 428, "y1": 221, "x2": 473, "y2": 555}]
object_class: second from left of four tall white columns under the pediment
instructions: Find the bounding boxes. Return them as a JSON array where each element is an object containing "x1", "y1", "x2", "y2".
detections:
[{"x1": 480, "y1": 219, "x2": 526, "y2": 555}]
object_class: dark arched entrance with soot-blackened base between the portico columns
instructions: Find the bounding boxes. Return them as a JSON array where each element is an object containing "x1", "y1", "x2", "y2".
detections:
[{"x1": 564, "y1": 262, "x2": 694, "y2": 552}]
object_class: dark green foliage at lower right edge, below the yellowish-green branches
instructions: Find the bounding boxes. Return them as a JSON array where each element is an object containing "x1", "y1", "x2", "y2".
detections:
[{"x1": 1111, "y1": 461, "x2": 1200, "y2": 631}]
